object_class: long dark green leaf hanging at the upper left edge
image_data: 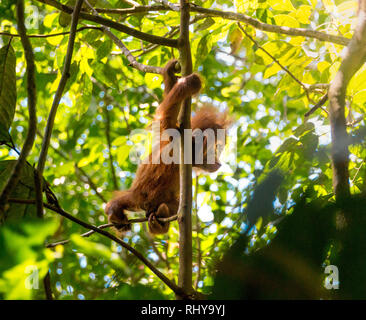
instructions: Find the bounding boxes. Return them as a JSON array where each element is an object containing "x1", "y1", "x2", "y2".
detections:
[{"x1": 0, "y1": 43, "x2": 17, "y2": 141}]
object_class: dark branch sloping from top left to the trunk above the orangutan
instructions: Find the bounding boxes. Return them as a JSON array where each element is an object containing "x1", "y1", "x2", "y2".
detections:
[{"x1": 36, "y1": 0, "x2": 178, "y2": 48}]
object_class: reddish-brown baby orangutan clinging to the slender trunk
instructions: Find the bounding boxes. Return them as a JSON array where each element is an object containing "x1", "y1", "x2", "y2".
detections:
[{"x1": 105, "y1": 60, "x2": 229, "y2": 234}]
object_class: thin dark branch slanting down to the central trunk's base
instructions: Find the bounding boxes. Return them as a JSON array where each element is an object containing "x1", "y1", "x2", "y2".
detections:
[{"x1": 8, "y1": 199, "x2": 186, "y2": 298}]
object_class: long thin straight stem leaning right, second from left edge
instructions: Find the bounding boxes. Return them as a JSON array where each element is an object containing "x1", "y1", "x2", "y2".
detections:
[{"x1": 36, "y1": 0, "x2": 83, "y2": 215}]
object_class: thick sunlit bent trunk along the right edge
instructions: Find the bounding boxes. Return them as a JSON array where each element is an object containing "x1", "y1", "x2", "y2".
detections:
[{"x1": 328, "y1": 0, "x2": 366, "y2": 199}]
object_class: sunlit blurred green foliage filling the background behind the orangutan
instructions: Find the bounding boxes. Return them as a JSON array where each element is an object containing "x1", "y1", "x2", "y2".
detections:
[{"x1": 0, "y1": 0, "x2": 366, "y2": 299}]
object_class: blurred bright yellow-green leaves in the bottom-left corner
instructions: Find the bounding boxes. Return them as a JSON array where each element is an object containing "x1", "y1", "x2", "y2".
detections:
[{"x1": 0, "y1": 218, "x2": 58, "y2": 299}]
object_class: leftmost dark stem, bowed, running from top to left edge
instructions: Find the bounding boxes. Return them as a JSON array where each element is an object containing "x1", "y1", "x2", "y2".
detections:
[{"x1": 0, "y1": 0, "x2": 37, "y2": 217}]
